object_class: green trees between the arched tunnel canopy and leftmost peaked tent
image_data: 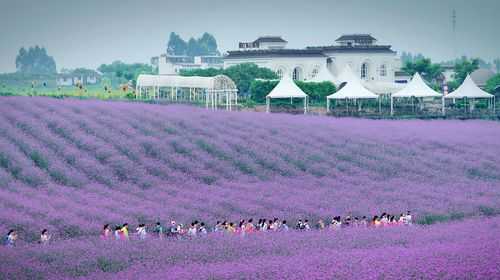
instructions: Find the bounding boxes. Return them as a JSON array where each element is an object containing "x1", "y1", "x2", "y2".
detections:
[{"x1": 180, "y1": 63, "x2": 278, "y2": 95}]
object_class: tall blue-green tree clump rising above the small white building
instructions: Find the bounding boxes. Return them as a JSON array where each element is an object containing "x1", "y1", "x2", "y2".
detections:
[{"x1": 167, "y1": 32, "x2": 219, "y2": 56}]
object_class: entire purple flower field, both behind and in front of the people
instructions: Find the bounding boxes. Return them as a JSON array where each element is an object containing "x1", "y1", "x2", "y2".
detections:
[{"x1": 0, "y1": 97, "x2": 500, "y2": 279}]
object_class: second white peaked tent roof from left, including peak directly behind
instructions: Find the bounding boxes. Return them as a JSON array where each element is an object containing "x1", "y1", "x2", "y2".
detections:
[{"x1": 326, "y1": 65, "x2": 378, "y2": 99}]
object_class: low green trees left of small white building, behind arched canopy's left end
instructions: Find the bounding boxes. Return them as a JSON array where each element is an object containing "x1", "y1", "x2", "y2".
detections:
[{"x1": 97, "y1": 61, "x2": 155, "y2": 84}]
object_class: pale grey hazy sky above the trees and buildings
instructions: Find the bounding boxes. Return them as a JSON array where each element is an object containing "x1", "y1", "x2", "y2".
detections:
[{"x1": 0, "y1": 0, "x2": 500, "y2": 72}]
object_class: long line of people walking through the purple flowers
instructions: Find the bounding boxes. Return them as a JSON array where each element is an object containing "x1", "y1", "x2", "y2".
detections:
[{"x1": 4, "y1": 211, "x2": 412, "y2": 247}]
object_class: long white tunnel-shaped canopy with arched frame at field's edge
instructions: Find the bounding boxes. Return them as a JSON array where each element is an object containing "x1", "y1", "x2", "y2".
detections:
[{"x1": 135, "y1": 74, "x2": 238, "y2": 110}]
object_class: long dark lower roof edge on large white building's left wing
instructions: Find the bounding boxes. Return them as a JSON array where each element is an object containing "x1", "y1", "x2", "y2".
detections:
[{"x1": 224, "y1": 49, "x2": 326, "y2": 59}]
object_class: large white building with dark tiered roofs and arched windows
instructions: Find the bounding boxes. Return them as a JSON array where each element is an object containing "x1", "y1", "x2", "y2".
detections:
[{"x1": 224, "y1": 34, "x2": 406, "y2": 93}]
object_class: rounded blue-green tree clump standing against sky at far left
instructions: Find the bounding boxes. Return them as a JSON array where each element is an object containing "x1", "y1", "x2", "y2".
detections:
[{"x1": 16, "y1": 45, "x2": 56, "y2": 74}]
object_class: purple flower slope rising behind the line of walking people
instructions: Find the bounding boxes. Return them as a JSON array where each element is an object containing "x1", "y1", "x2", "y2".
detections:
[{"x1": 0, "y1": 97, "x2": 500, "y2": 240}]
